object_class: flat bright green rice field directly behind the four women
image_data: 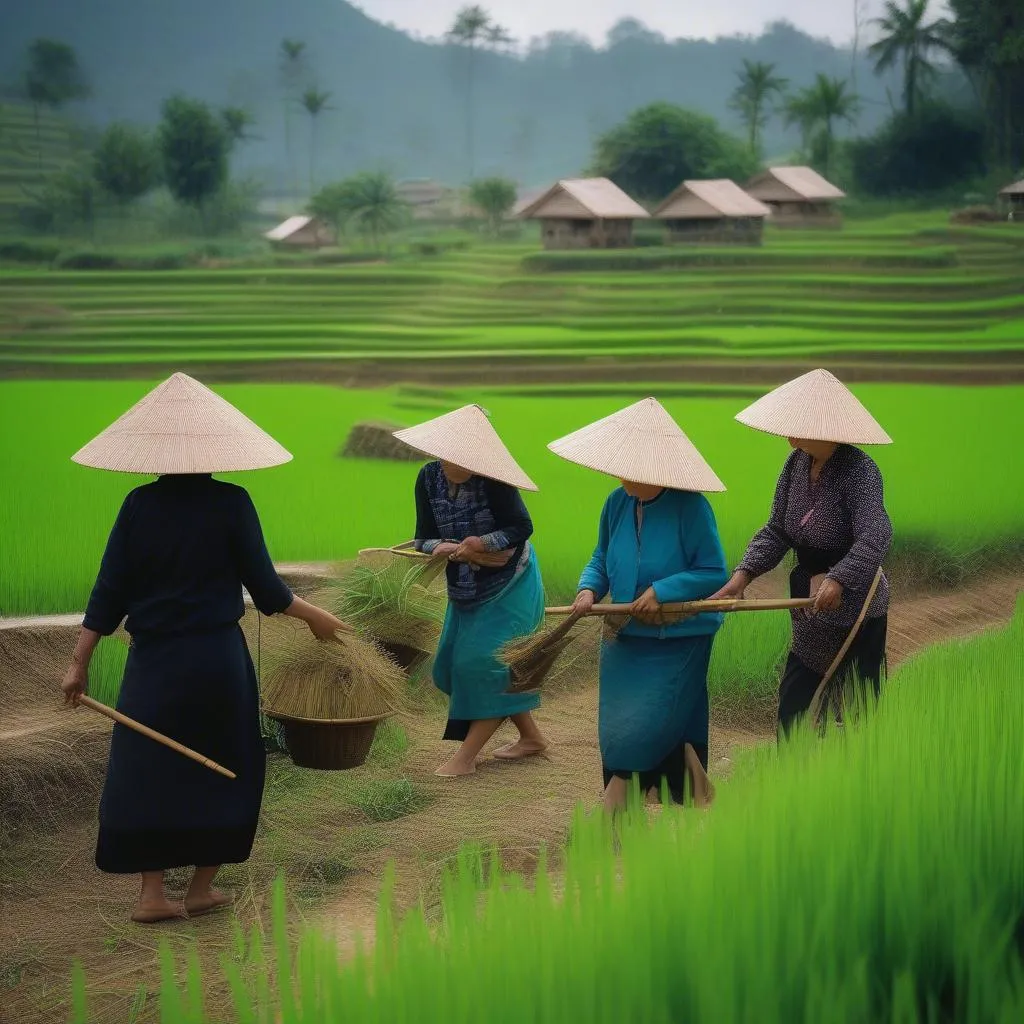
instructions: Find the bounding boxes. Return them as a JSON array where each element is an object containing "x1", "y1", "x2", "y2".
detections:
[{"x1": 0, "y1": 381, "x2": 1024, "y2": 712}]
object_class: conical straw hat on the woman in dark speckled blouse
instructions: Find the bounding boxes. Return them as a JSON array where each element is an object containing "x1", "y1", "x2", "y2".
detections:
[{"x1": 736, "y1": 370, "x2": 892, "y2": 444}]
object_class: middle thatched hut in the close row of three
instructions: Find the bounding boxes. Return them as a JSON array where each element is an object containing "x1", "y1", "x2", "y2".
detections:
[{"x1": 654, "y1": 178, "x2": 771, "y2": 246}]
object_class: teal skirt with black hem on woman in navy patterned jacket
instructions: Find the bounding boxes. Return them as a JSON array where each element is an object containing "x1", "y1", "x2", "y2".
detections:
[{"x1": 433, "y1": 551, "x2": 544, "y2": 740}]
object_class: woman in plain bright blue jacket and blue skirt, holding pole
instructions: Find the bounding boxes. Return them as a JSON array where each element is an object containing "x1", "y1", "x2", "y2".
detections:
[{"x1": 549, "y1": 398, "x2": 728, "y2": 811}]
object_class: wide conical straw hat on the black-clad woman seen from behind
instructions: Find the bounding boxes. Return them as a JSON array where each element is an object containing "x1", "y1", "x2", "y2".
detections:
[{"x1": 72, "y1": 374, "x2": 292, "y2": 475}]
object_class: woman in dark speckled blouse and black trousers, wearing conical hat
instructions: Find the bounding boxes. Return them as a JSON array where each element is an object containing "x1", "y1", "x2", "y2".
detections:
[{"x1": 715, "y1": 370, "x2": 893, "y2": 736}]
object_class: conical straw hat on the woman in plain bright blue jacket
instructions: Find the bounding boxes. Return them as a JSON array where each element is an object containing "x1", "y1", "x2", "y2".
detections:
[{"x1": 548, "y1": 398, "x2": 725, "y2": 490}]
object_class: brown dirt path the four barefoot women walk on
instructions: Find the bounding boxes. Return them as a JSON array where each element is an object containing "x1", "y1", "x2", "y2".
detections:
[{"x1": 0, "y1": 572, "x2": 1024, "y2": 1024}]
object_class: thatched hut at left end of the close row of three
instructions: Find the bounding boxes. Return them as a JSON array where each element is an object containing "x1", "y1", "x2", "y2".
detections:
[{"x1": 515, "y1": 178, "x2": 650, "y2": 249}]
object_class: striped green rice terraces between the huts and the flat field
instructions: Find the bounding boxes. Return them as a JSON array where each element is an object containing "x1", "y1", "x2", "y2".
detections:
[{"x1": 0, "y1": 218, "x2": 1024, "y2": 384}]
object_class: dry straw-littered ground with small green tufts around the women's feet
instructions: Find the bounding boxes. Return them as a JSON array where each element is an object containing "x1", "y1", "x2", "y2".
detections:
[{"x1": 0, "y1": 573, "x2": 1020, "y2": 1024}]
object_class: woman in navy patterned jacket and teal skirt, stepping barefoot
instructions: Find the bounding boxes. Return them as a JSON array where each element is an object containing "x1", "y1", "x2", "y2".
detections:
[{"x1": 395, "y1": 406, "x2": 548, "y2": 777}]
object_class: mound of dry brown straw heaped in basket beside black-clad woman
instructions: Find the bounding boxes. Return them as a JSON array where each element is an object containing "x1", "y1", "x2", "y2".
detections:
[{"x1": 262, "y1": 620, "x2": 409, "y2": 722}]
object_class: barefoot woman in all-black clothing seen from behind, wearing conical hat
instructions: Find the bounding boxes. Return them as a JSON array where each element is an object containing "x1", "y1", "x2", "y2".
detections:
[{"x1": 63, "y1": 374, "x2": 344, "y2": 924}]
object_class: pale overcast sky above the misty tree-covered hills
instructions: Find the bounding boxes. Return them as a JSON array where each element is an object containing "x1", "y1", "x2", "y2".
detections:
[{"x1": 354, "y1": 0, "x2": 939, "y2": 43}]
